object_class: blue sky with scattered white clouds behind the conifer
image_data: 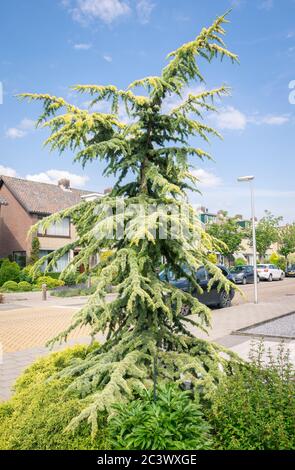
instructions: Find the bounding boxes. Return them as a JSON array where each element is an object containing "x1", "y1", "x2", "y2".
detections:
[{"x1": 0, "y1": 0, "x2": 295, "y2": 221}]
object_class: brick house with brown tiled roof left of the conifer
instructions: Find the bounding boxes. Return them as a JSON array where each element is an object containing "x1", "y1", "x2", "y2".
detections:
[{"x1": 0, "y1": 176, "x2": 101, "y2": 272}]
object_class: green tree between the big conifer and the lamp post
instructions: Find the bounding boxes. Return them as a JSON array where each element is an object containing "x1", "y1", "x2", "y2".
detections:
[{"x1": 206, "y1": 212, "x2": 245, "y2": 262}]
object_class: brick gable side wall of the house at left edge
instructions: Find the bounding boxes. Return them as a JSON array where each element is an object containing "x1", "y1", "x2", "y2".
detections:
[{"x1": 0, "y1": 184, "x2": 33, "y2": 258}]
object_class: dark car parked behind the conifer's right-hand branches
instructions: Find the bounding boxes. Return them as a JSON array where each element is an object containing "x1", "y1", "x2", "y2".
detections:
[{"x1": 160, "y1": 266, "x2": 235, "y2": 313}]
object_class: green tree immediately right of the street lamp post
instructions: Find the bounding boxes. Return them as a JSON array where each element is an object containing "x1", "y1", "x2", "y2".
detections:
[{"x1": 252, "y1": 211, "x2": 282, "y2": 259}]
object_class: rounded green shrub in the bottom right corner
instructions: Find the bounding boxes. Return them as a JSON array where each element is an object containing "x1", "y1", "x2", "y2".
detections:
[{"x1": 208, "y1": 346, "x2": 295, "y2": 450}]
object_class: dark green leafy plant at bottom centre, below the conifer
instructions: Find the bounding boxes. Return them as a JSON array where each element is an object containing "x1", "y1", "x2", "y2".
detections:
[{"x1": 109, "y1": 385, "x2": 211, "y2": 450}]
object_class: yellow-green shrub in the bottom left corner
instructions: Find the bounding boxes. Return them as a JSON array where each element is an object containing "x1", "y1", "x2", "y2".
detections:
[{"x1": 0, "y1": 345, "x2": 108, "y2": 450}]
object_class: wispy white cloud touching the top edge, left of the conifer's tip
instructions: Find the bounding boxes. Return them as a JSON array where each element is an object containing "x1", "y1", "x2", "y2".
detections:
[{"x1": 70, "y1": 0, "x2": 131, "y2": 24}]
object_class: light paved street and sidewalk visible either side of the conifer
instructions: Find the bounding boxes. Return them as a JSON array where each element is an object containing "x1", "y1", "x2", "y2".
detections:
[{"x1": 0, "y1": 296, "x2": 295, "y2": 400}]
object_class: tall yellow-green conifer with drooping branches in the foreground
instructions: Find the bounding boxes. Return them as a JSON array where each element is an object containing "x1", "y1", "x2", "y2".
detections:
[{"x1": 22, "y1": 11, "x2": 237, "y2": 432}]
